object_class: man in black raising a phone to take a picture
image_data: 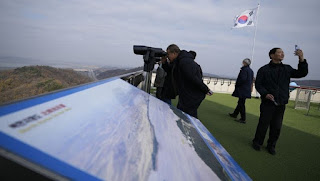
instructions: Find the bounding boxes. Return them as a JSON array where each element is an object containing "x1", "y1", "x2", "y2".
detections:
[{"x1": 252, "y1": 48, "x2": 308, "y2": 155}]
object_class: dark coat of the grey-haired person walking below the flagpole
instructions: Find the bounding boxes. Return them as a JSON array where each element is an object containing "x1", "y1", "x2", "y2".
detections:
[{"x1": 232, "y1": 66, "x2": 253, "y2": 98}]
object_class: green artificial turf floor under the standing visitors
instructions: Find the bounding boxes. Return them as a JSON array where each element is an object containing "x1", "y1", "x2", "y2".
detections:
[{"x1": 173, "y1": 93, "x2": 320, "y2": 181}]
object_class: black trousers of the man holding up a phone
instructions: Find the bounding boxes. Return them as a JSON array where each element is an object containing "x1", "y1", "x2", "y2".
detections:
[{"x1": 253, "y1": 101, "x2": 286, "y2": 148}]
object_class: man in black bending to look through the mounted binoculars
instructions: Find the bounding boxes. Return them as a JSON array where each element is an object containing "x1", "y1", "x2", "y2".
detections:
[{"x1": 167, "y1": 44, "x2": 212, "y2": 118}]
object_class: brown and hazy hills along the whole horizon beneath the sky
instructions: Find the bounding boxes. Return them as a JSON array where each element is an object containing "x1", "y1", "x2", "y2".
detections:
[{"x1": 0, "y1": 56, "x2": 320, "y2": 104}]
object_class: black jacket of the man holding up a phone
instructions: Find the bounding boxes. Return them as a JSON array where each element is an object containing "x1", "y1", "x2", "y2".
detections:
[{"x1": 255, "y1": 60, "x2": 308, "y2": 105}]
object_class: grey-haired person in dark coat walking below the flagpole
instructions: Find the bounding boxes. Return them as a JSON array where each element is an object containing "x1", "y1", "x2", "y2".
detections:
[{"x1": 229, "y1": 58, "x2": 253, "y2": 123}]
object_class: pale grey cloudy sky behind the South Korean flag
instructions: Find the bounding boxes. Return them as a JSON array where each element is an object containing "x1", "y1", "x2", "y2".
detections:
[{"x1": 0, "y1": 0, "x2": 320, "y2": 80}]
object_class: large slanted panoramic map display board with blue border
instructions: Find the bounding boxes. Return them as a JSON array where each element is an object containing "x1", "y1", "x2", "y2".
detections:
[{"x1": 0, "y1": 78, "x2": 250, "y2": 181}]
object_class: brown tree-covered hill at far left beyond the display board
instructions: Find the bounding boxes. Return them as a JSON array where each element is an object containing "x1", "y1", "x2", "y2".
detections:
[{"x1": 0, "y1": 66, "x2": 92, "y2": 104}]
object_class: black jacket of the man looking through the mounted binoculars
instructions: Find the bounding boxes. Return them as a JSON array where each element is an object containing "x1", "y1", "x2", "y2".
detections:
[{"x1": 175, "y1": 50, "x2": 209, "y2": 107}]
